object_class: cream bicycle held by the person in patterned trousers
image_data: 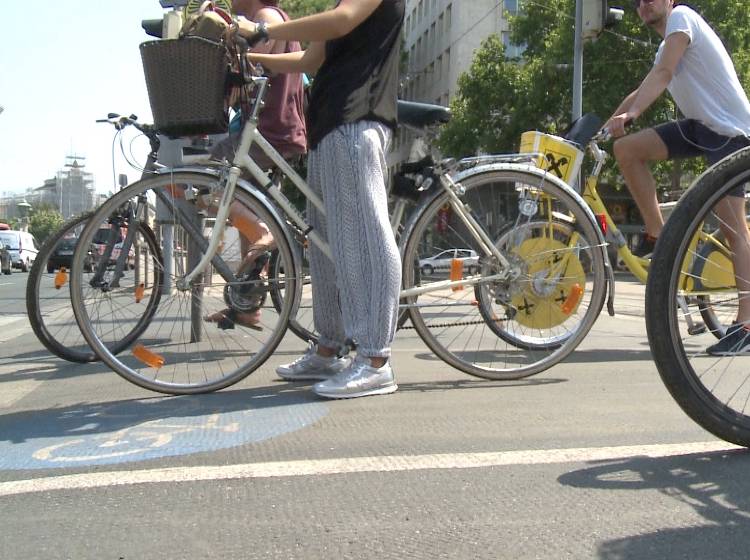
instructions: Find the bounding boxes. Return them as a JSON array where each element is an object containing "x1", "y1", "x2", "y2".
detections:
[{"x1": 66, "y1": 36, "x2": 607, "y2": 394}]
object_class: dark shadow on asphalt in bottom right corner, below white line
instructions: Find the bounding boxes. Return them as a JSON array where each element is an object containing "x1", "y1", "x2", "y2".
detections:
[{"x1": 558, "y1": 450, "x2": 750, "y2": 560}]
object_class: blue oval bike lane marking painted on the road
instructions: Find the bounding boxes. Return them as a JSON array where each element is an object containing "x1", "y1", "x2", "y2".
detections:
[{"x1": 0, "y1": 391, "x2": 328, "y2": 470}]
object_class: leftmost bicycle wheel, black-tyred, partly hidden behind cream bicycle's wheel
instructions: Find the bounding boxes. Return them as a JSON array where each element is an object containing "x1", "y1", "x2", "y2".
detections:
[{"x1": 26, "y1": 211, "x2": 159, "y2": 363}]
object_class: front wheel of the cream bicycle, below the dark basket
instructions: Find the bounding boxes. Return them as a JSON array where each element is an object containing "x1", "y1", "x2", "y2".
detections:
[{"x1": 71, "y1": 172, "x2": 296, "y2": 394}]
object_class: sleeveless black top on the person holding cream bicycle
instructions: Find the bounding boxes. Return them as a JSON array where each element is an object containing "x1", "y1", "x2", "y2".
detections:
[{"x1": 307, "y1": 0, "x2": 406, "y2": 149}]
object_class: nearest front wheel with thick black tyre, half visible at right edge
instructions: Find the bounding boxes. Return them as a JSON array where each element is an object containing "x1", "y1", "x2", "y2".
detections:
[{"x1": 646, "y1": 149, "x2": 750, "y2": 446}]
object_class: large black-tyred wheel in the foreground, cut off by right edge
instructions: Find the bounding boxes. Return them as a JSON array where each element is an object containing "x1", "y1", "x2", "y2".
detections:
[{"x1": 646, "y1": 149, "x2": 750, "y2": 447}]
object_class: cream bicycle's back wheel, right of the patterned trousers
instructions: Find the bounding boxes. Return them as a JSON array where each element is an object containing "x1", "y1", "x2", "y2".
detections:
[{"x1": 403, "y1": 166, "x2": 607, "y2": 379}]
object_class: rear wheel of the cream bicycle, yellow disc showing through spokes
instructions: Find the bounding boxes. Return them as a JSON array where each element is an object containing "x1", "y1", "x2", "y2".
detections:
[{"x1": 403, "y1": 168, "x2": 606, "y2": 379}]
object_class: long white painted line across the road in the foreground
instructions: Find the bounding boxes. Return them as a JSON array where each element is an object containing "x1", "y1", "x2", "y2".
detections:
[{"x1": 0, "y1": 441, "x2": 744, "y2": 496}]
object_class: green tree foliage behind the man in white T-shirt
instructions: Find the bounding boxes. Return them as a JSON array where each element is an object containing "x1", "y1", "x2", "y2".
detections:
[{"x1": 440, "y1": 0, "x2": 750, "y2": 188}]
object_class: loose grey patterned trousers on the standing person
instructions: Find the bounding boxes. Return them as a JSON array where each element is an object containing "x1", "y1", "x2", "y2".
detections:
[{"x1": 307, "y1": 121, "x2": 401, "y2": 357}]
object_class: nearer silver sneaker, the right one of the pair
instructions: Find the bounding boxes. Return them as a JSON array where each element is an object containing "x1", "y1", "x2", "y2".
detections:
[{"x1": 313, "y1": 358, "x2": 398, "y2": 399}]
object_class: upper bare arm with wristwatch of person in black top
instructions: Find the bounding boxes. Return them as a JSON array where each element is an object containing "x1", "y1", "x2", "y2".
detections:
[{"x1": 238, "y1": 0, "x2": 383, "y2": 42}]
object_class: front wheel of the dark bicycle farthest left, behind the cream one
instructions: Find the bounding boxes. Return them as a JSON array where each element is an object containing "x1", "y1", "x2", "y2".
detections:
[{"x1": 26, "y1": 212, "x2": 161, "y2": 363}]
